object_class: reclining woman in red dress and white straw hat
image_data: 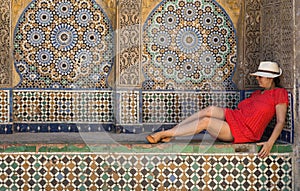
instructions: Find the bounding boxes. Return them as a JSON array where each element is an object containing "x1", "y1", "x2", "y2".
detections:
[{"x1": 146, "y1": 61, "x2": 288, "y2": 158}]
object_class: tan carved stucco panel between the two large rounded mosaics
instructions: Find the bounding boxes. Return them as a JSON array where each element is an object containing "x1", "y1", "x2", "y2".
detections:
[{"x1": 116, "y1": 0, "x2": 141, "y2": 87}]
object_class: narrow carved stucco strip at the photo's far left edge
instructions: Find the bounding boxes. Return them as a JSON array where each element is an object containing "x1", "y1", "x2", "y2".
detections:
[{"x1": 0, "y1": 0, "x2": 11, "y2": 87}]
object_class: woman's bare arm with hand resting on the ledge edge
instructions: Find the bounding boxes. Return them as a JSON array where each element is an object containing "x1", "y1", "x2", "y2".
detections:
[{"x1": 257, "y1": 103, "x2": 287, "y2": 158}]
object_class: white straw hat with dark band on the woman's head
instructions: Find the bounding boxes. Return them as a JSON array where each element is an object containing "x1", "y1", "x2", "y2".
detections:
[{"x1": 250, "y1": 61, "x2": 282, "y2": 78}]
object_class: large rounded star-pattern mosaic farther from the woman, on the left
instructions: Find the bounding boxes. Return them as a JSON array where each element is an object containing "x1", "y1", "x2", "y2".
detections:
[{"x1": 14, "y1": 0, "x2": 113, "y2": 89}]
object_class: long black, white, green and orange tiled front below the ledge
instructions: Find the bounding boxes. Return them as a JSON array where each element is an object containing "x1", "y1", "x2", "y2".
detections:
[{"x1": 0, "y1": 153, "x2": 293, "y2": 191}]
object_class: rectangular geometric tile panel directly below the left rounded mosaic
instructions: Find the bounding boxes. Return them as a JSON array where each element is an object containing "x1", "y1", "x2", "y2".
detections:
[{"x1": 13, "y1": 90, "x2": 114, "y2": 123}]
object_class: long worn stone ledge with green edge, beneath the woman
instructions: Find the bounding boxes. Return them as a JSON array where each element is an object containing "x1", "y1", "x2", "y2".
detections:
[{"x1": 0, "y1": 132, "x2": 293, "y2": 154}]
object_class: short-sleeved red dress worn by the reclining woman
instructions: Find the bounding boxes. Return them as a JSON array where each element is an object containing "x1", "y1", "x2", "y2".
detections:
[{"x1": 225, "y1": 88, "x2": 288, "y2": 143}]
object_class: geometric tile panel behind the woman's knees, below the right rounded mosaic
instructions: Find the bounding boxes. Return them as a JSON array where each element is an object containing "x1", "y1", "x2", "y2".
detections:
[{"x1": 142, "y1": 91, "x2": 241, "y2": 123}]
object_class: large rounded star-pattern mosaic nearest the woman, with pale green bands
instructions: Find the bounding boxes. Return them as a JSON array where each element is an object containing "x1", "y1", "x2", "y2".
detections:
[{"x1": 143, "y1": 0, "x2": 237, "y2": 90}]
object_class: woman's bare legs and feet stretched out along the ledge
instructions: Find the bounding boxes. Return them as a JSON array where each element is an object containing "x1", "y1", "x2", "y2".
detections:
[{"x1": 147, "y1": 117, "x2": 233, "y2": 143}]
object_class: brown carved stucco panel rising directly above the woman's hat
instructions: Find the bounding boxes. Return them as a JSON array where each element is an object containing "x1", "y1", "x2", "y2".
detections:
[{"x1": 261, "y1": 0, "x2": 294, "y2": 89}]
